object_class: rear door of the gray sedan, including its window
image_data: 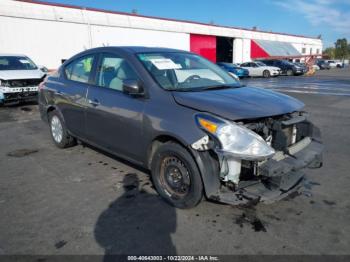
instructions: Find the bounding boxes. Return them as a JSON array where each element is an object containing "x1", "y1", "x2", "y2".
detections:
[{"x1": 55, "y1": 54, "x2": 96, "y2": 138}]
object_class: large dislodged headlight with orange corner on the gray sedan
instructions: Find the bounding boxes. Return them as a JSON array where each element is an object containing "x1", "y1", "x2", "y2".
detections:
[{"x1": 196, "y1": 114, "x2": 275, "y2": 160}]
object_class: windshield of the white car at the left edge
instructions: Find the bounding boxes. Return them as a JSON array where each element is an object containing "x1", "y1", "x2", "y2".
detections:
[{"x1": 0, "y1": 56, "x2": 38, "y2": 70}]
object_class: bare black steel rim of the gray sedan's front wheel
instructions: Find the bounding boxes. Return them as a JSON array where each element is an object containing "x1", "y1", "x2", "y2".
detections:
[{"x1": 160, "y1": 156, "x2": 191, "y2": 199}]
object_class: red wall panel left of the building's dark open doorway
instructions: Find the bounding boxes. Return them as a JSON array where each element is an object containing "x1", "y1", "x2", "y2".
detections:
[{"x1": 190, "y1": 34, "x2": 216, "y2": 63}]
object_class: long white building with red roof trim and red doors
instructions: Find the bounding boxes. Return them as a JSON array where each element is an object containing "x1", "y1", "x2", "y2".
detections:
[{"x1": 0, "y1": 0, "x2": 322, "y2": 69}]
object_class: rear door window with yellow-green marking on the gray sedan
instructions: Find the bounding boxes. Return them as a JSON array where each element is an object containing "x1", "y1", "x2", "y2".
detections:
[{"x1": 65, "y1": 55, "x2": 94, "y2": 83}]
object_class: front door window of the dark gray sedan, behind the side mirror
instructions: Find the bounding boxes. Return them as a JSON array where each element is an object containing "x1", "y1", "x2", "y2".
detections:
[{"x1": 96, "y1": 54, "x2": 138, "y2": 91}]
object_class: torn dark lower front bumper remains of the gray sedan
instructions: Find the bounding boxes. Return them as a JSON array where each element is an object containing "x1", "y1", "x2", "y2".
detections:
[{"x1": 219, "y1": 138, "x2": 323, "y2": 205}]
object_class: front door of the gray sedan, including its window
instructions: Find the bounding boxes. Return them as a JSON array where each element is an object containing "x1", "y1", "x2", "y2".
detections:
[{"x1": 86, "y1": 53, "x2": 145, "y2": 162}]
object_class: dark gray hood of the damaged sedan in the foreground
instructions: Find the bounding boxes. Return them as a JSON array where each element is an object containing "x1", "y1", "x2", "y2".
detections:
[{"x1": 172, "y1": 87, "x2": 304, "y2": 120}]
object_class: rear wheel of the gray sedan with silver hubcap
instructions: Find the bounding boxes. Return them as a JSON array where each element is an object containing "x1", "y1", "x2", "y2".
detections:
[{"x1": 49, "y1": 111, "x2": 76, "y2": 148}]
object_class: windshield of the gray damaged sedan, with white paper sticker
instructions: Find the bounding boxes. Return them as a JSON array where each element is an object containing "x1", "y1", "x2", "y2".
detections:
[{"x1": 138, "y1": 52, "x2": 240, "y2": 91}]
